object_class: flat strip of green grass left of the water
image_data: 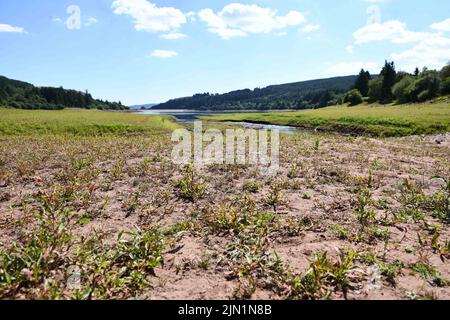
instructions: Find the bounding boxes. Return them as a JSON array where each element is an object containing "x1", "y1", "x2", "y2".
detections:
[{"x1": 0, "y1": 109, "x2": 178, "y2": 136}]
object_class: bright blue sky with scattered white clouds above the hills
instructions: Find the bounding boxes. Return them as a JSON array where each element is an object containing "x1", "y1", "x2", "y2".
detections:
[{"x1": 0, "y1": 0, "x2": 450, "y2": 105}]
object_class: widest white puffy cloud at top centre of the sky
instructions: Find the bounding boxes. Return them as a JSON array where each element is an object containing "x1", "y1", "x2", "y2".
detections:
[{"x1": 198, "y1": 3, "x2": 306, "y2": 39}]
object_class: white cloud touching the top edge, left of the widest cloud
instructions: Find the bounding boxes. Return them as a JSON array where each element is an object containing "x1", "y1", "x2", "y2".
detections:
[{"x1": 112, "y1": 0, "x2": 187, "y2": 32}]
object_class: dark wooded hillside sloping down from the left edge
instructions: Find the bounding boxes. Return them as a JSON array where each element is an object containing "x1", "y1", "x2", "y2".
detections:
[{"x1": 0, "y1": 76, "x2": 127, "y2": 110}]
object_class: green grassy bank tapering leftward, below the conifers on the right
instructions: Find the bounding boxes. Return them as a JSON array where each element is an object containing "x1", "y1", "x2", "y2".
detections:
[{"x1": 202, "y1": 99, "x2": 450, "y2": 137}]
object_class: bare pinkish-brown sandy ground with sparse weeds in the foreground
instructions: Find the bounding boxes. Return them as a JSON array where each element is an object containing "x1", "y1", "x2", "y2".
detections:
[{"x1": 0, "y1": 135, "x2": 450, "y2": 299}]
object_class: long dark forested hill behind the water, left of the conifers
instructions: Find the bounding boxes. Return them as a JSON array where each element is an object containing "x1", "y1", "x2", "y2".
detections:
[{"x1": 153, "y1": 76, "x2": 357, "y2": 110}]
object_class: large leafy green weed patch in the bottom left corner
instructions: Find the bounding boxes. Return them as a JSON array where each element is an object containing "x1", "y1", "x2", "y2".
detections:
[{"x1": 0, "y1": 207, "x2": 168, "y2": 299}]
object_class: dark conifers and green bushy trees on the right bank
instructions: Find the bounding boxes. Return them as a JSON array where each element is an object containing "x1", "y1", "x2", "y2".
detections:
[{"x1": 343, "y1": 61, "x2": 450, "y2": 105}]
